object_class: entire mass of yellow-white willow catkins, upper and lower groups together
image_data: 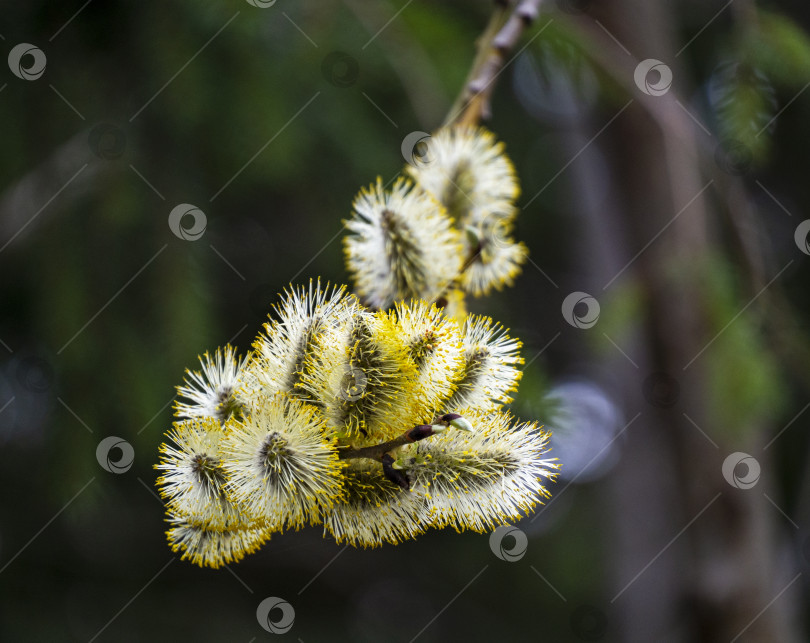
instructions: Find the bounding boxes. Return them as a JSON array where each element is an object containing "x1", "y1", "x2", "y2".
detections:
[{"x1": 156, "y1": 130, "x2": 558, "y2": 567}]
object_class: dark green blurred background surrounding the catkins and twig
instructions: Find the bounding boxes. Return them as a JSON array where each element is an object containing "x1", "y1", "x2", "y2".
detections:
[{"x1": 0, "y1": 0, "x2": 810, "y2": 643}]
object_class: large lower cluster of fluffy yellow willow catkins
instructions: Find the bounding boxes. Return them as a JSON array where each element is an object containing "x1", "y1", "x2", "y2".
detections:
[{"x1": 156, "y1": 283, "x2": 557, "y2": 567}]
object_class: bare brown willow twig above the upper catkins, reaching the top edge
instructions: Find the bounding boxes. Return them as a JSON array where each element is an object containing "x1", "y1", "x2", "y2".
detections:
[{"x1": 444, "y1": 0, "x2": 542, "y2": 127}]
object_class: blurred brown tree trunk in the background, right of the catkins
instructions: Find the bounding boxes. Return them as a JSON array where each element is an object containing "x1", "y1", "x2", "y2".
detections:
[{"x1": 576, "y1": 0, "x2": 798, "y2": 643}]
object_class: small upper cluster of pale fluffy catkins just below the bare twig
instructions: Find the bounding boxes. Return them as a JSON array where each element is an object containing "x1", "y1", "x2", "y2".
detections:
[{"x1": 344, "y1": 127, "x2": 528, "y2": 318}]
